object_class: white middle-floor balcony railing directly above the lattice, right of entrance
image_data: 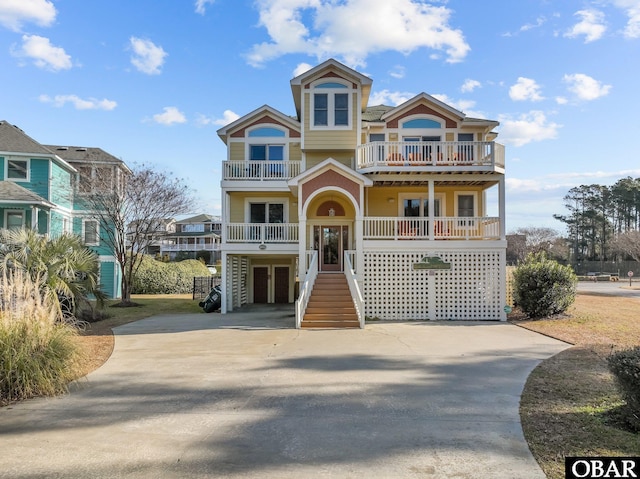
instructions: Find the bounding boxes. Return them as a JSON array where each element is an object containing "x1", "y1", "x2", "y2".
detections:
[{"x1": 363, "y1": 216, "x2": 500, "y2": 240}]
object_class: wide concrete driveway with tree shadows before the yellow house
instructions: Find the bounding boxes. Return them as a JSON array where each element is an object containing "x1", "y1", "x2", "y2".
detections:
[{"x1": 0, "y1": 308, "x2": 567, "y2": 479}]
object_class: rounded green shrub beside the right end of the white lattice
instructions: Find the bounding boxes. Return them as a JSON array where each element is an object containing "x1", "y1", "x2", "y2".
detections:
[{"x1": 513, "y1": 253, "x2": 577, "y2": 318}]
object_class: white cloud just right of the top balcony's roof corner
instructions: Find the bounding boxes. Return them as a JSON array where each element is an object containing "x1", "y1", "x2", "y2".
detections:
[{"x1": 498, "y1": 110, "x2": 562, "y2": 146}]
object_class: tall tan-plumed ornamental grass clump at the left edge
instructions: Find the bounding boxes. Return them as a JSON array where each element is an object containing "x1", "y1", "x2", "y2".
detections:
[{"x1": 0, "y1": 270, "x2": 84, "y2": 404}]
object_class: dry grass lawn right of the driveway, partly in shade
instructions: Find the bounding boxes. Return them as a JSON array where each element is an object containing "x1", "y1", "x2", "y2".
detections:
[{"x1": 512, "y1": 294, "x2": 640, "y2": 479}]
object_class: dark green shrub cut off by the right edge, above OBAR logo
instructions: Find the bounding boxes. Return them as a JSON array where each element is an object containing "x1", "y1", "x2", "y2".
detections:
[{"x1": 607, "y1": 346, "x2": 640, "y2": 431}]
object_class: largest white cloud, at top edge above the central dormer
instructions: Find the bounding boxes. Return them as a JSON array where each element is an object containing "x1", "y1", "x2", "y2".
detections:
[{"x1": 247, "y1": 0, "x2": 470, "y2": 67}]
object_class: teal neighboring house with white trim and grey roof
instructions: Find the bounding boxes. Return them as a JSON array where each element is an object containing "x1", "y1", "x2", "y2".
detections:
[{"x1": 0, "y1": 120, "x2": 130, "y2": 298}]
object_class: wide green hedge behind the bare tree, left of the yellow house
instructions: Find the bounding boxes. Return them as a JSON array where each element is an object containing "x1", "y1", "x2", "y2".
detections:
[{"x1": 132, "y1": 256, "x2": 209, "y2": 294}]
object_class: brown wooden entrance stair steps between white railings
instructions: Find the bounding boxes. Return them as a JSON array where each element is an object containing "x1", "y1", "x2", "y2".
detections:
[{"x1": 300, "y1": 273, "x2": 360, "y2": 328}]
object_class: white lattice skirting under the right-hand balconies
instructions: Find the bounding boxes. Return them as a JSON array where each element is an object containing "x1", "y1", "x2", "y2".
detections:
[{"x1": 364, "y1": 249, "x2": 506, "y2": 321}]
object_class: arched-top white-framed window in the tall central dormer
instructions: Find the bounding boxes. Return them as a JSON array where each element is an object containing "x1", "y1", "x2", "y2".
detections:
[{"x1": 312, "y1": 82, "x2": 351, "y2": 128}]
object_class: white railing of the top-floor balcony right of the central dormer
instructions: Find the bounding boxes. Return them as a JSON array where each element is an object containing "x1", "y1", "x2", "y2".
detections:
[{"x1": 356, "y1": 141, "x2": 504, "y2": 169}]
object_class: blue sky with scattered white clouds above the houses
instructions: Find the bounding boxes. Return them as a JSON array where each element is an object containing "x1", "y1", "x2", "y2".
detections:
[{"x1": 0, "y1": 0, "x2": 640, "y2": 232}]
